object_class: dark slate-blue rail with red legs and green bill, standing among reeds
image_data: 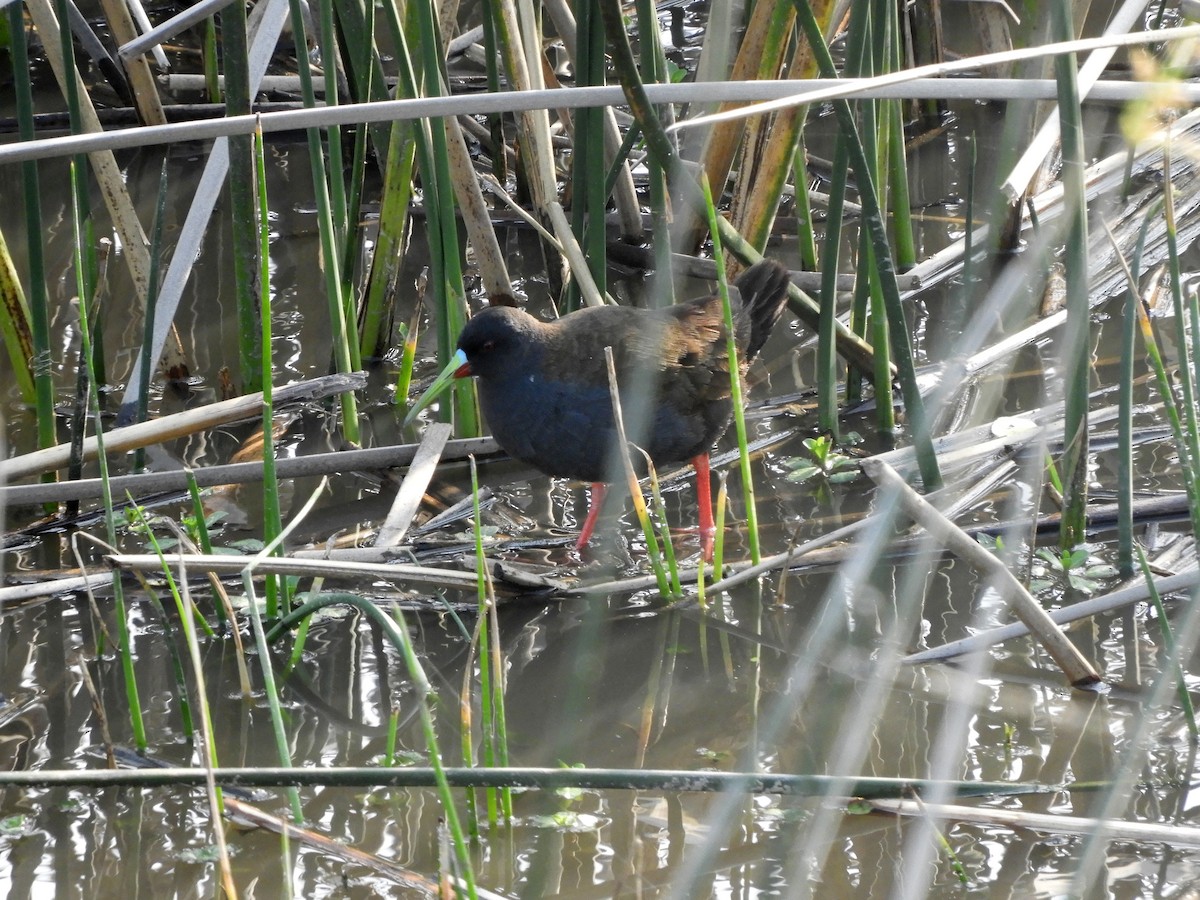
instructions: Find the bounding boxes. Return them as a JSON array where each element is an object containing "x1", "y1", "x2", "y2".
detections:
[{"x1": 406, "y1": 259, "x2": 787, "y2": 558}]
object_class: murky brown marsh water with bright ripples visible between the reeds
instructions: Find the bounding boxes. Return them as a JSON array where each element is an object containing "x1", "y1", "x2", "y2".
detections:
[{"x1": 0, "y1": 22, "x2": 1200, "y2": 898}]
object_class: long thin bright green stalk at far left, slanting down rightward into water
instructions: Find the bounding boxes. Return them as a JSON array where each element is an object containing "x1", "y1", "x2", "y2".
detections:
[{"x1": 71, "y1": 160, "x2": 148, "y2": 752}]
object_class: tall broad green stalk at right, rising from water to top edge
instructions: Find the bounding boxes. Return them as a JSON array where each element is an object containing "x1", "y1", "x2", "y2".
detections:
[{"x1": 1050, "y1": 0, "x2": 1091, "y2": 551}]
